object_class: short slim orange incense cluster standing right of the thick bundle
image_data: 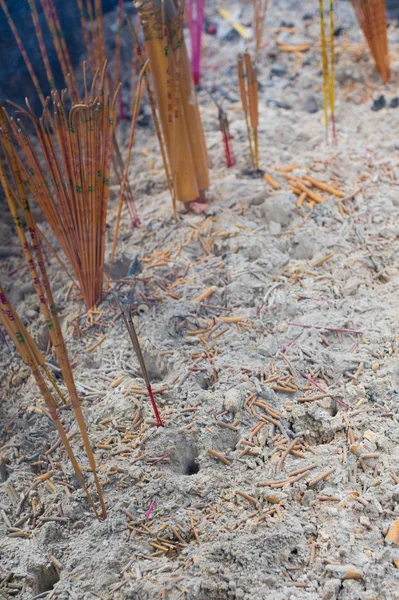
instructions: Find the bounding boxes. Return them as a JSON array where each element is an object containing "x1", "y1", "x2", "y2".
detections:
[{"x1": 238, "y1": 52, "x2": 259, "y2": 171}]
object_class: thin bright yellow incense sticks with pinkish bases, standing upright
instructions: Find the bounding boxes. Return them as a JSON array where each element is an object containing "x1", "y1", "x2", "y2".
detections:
[{"x1": 319, "y1": 0, "x2": 337, "y2": 145}]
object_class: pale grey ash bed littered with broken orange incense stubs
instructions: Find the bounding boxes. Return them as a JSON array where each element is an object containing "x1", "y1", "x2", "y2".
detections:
[{"x1": 0, "y1": 1, "x2": 399, "y2": 600}]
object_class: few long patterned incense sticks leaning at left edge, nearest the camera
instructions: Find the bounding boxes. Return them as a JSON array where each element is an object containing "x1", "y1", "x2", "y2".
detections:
[{"x1": 0, "y1": 111, "x2": 106, "y2": 517}]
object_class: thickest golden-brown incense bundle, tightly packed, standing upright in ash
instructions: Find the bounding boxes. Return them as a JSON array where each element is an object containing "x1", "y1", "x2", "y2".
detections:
[{"x1": 132, "y1": 0, "x2": 209, "y2": 214}]
